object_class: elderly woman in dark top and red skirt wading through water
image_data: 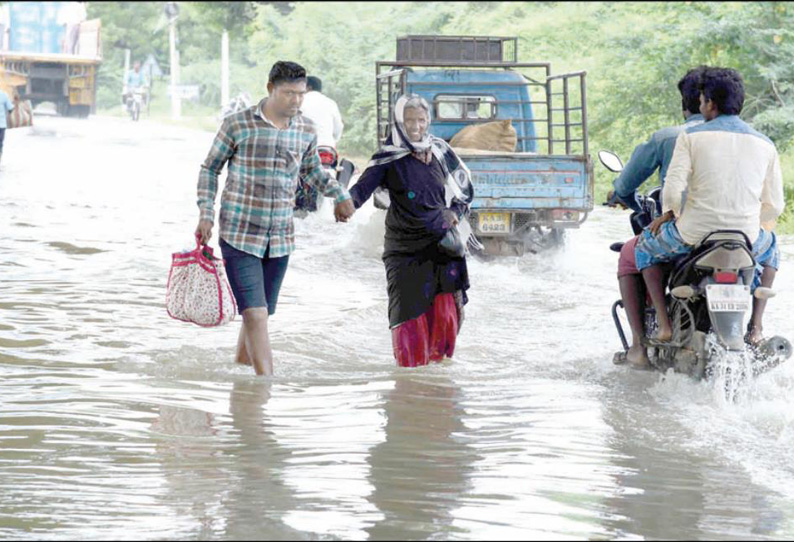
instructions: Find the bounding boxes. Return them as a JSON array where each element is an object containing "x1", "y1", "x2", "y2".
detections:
[{"x1": 350, "y1": 95, "x2": 476, "y2": 367}]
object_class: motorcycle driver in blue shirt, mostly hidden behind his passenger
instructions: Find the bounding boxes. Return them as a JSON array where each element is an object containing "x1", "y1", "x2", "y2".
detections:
[{"x1": 607, "y1": 66, "x2": 705, "y2": 367}]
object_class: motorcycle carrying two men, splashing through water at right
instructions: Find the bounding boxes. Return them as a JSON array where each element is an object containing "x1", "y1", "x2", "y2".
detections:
[{"x1": 598, "y1": 151, "x2": 792, "y2": 379}]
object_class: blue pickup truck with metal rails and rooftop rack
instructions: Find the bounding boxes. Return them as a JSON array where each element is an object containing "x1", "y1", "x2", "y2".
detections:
[{"x1": 376, "y1": 36, "x2": 594, "y2": 255}]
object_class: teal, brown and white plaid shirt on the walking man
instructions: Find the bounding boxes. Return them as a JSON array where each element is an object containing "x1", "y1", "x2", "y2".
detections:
[{"x1": 198, "y1": 98, "x2": 350, "y2": 258}]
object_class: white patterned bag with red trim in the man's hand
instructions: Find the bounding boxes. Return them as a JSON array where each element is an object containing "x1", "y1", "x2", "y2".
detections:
[{"x1": 165, "y1": 239, "x2": 237, "y2": 327}]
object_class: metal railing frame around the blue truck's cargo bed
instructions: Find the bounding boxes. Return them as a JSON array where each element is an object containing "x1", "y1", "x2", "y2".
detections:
[{"x1": 375, "y1": 60, "x2": 589, "y2": 156}]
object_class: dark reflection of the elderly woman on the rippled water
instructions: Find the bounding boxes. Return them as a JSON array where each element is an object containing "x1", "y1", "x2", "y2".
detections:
[{"x1": 367, "y1": 375, "x2": 477, "y2": 540}]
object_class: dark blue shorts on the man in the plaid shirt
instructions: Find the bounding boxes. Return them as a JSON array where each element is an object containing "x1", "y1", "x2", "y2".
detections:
[{"x1": 220, "y1": 239, "x2": 289, "y2": 316}]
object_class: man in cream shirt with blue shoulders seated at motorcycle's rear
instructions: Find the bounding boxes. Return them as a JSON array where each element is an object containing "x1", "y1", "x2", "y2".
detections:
[{"x1": 635, "y1": 68, "x2": 785, "y2": 344}]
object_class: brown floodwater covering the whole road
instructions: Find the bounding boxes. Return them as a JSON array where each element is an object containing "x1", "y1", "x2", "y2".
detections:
[{"x1": 0, "y1": 117, "x2": 794, "y2": 540}]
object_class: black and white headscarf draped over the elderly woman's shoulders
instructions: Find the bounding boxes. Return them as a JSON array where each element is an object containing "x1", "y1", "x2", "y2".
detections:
[{"x1": 367, "y1": 94, "x2": 482, "y2": 253}]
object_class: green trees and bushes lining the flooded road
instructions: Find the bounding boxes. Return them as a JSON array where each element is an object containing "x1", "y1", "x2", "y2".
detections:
[{"x1": 88, "y1": 2, "x2": 794, "y2": 233}]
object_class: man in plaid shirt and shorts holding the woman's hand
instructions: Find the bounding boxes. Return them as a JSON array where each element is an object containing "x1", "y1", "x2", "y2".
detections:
[{"x1": 196, "y1": 61, "x2": 354, "y2": 376}]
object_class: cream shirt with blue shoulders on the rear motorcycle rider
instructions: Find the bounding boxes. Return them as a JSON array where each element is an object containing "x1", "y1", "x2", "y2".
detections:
[{"x1": 662, "y1": 115, "x2": 785, "y2": 245}]
